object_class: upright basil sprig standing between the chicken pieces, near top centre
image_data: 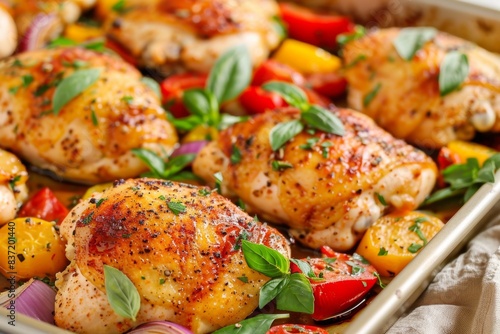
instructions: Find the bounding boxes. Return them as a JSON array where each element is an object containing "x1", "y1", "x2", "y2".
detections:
[{"x1": 167, "y1": 45, "x2": 252, "y2": 131}]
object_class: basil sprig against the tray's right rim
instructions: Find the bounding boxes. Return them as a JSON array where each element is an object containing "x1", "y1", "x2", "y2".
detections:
[{"x1": 423, "y1": 153, "x2": 500, "y2": 205}]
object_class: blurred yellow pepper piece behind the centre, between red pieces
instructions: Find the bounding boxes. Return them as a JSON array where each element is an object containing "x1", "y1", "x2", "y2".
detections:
[{"x1": 273, "y1": 39, "x2": 341, "y2": 74}]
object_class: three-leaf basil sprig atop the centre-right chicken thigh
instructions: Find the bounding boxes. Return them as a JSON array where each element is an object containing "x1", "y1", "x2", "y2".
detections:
[{"x1": 262, "y1": 81, "x2": 345, "y2": 151}]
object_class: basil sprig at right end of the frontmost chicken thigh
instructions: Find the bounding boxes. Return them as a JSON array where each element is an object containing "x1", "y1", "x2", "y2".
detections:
[{"x1": 241, "y1": 240, "x2": 314, "y2": 314}]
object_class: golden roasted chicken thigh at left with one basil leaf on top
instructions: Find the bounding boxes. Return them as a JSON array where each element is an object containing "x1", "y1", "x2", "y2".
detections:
[{"x1": 0, "y1": 48, "x2": 177, "y2": 183}]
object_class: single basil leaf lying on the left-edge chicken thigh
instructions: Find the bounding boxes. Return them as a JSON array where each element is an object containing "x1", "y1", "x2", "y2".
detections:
[{"x1": 52, "y1": 68, "x2": 101, "y2": 115}]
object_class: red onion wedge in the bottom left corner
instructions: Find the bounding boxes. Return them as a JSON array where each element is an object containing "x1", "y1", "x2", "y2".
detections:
[{"x1": 0, "y1": 279, "x2": 56, "y2": 324}]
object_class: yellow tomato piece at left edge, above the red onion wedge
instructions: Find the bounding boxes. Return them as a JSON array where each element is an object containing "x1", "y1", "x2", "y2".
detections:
[{"x1": 0, "y1": 218, "x2": 68, "y2": 280}]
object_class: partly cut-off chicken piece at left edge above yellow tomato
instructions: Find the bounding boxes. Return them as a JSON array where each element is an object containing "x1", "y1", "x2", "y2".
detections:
[{"x1": 0, "y1": 149, "x2": 28, "y2": 226}]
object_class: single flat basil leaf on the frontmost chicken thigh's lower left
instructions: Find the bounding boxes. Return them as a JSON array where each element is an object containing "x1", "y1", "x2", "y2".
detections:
[{"x1": 104, "y1": 265, "x2": 141, "y2": 321}]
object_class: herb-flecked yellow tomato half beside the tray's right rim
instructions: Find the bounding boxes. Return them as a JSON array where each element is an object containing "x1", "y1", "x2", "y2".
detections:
[{"x1": 356, "y1": 211, "x2": 444, "y2": 276}]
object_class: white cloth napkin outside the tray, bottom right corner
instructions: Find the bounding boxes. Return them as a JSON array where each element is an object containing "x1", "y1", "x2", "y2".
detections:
[{"x1": 387, "y1": 214, "x2": 500, "y2": 334}]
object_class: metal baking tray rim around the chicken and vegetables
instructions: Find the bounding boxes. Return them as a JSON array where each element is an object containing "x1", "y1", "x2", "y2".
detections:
[{"x1": 0, "y1": 0, "x2": 500, "y2": 334}]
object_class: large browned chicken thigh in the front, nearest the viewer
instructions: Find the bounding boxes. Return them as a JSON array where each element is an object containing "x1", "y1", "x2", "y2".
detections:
[{"x1": 55, "y1": 179, "x2": 290, "y2": 334}]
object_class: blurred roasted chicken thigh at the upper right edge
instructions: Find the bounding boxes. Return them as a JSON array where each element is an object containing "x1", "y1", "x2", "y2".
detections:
[{"x1": 344, "y1": 28, "x2": 500, "y2": 148}]
